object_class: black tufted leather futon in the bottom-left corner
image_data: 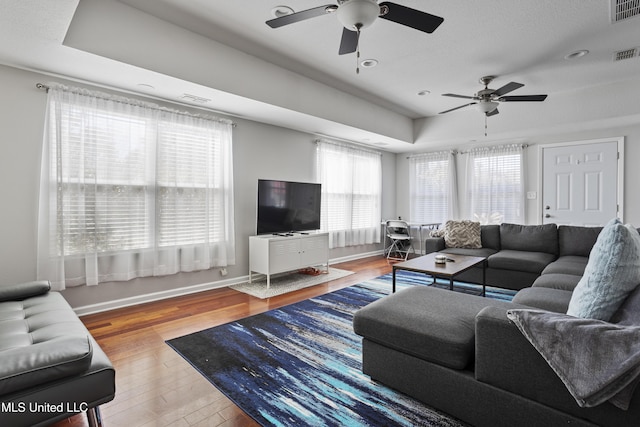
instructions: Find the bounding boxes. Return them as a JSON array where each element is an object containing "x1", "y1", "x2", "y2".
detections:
[{"x1": 0, "y1": 281, "x2": 115, "y2": 427}]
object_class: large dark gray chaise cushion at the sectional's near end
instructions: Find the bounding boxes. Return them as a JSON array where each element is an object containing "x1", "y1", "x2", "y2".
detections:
[{"x1": 353, "y1": 286, "x2": 510, "y2": 369}]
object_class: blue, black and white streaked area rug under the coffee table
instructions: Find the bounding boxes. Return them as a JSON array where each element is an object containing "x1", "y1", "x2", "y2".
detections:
[{"x1": 167, "y1": 272, "x2": 516, "y2": 426}]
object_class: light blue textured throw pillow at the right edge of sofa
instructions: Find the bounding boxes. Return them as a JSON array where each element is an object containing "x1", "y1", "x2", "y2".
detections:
[{"x1": 567, "y1": 218, "x2": 640, "y2": 321}]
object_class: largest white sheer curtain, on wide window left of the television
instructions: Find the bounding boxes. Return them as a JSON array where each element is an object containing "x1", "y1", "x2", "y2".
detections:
[{"x1": 37, "y1": 85, "x2": 235, "y2": 289}]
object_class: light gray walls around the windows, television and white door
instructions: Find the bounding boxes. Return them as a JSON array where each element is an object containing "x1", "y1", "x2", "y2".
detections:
[{"x1": 0, "y1": 61, "x2": 640, "y2": 312}]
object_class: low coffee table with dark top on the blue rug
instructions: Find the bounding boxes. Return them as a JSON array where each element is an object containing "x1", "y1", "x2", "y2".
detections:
[{"x1": 392, "y1": 252, "x2": 487, "y2": 296}]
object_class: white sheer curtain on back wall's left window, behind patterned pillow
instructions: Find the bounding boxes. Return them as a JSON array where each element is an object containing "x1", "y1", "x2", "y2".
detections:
[{"x1": 409, "y1": 151, "x2": 458, "y2": 224}]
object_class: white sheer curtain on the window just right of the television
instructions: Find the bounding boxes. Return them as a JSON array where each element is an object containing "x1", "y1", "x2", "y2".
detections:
[{"x1": 316, "y1": 140, "x2": 382, "y2": 248}]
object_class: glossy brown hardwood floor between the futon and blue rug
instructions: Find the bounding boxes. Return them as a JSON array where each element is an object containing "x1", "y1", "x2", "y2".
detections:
[{"x1": 55, "y1": 256, "x2": 391, "y2": 427}]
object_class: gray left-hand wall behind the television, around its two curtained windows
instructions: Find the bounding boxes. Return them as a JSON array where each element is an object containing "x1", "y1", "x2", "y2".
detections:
[{"x1": 0, "y1": 66, "x2": 396, "y2": 307}]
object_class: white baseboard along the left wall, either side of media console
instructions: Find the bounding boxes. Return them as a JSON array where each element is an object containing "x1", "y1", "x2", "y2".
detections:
[{"x1": 73, "y1": 251, "x2": 381, "y2": 316}]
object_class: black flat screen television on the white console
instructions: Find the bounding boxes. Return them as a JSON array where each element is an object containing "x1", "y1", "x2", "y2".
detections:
[{"x1": 257, "y1": 179, "x2": 321, "y2": 234}]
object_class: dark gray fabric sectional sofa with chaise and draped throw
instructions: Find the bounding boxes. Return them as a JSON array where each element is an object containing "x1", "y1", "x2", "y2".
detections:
[{"x1": 353, "y1": 224, "x2": 640, "y2": 427}]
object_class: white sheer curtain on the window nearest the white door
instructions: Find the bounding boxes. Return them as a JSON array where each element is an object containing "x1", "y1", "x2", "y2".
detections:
[{"x1": 467, "y1": 144, "x2": 525, "y2": 224}]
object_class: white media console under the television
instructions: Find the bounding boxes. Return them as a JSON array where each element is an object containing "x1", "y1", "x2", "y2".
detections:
[{"x1": 249, "y1": 233, "x2": 329, "y2": 288}]
